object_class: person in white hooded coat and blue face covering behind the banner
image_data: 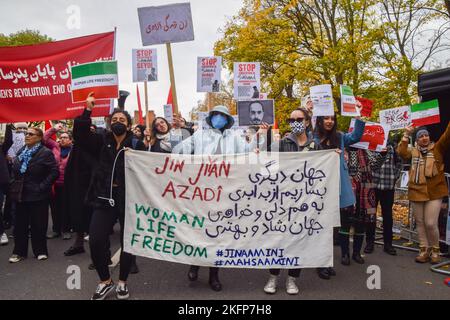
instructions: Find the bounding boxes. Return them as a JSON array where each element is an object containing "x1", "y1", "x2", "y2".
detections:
[{"x1": 172, "y1": 106, "x2": 269, "y2": 291}]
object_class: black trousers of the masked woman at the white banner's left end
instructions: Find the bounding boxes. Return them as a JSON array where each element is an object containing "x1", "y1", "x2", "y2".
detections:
[{"x1": 89, "y1": 207, "x2": 133, "y2": 281}]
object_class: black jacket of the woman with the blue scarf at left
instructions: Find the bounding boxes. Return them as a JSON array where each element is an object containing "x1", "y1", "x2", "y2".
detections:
[{"x1": 12, "y1": 145, "x2": 59, "y2": 202}]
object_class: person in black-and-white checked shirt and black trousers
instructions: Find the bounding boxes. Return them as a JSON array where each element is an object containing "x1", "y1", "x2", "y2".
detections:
[{"x1": 364, "y1": 142, "x2": 402, "y2": 256}]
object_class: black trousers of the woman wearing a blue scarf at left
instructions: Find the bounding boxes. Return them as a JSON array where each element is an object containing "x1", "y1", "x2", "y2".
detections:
[{"x1": 13, "y1": 200, "x2": 48, "y2": 257}]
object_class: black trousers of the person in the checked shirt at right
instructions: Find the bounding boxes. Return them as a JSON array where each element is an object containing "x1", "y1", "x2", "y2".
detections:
[{"x1": 366, "y1": 189, "x2": 395, "y2": 247}]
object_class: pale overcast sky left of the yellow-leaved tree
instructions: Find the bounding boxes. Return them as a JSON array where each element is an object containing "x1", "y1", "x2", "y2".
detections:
[{"x1": 0, "y1": 0, "x2": 242, "y2": 117}]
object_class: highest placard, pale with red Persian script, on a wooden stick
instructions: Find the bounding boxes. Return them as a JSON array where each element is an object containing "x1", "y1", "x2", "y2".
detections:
[{"x1": 138, "y1": 3, "x2": 194, "y2": 46}]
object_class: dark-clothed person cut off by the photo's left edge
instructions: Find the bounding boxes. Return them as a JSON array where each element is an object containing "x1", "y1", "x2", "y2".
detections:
[{"x1": 0, "y1": 125, "x2": 12, "y2": 246}]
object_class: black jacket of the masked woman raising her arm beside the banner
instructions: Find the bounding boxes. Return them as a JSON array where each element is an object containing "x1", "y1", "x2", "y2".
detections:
[{"x1": 74, "y1": 110, "x2": 146, "y2": 209}]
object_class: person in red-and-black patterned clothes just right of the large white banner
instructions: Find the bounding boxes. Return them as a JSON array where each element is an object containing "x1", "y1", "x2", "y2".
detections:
[{"x1": 346, "y1": 147, "x2": 386, "y2": 266}]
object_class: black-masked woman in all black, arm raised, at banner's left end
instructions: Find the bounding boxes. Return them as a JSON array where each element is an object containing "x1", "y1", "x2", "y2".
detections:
[{"x1": 74, "y1": 93, "x2": 145, "y2": 300}]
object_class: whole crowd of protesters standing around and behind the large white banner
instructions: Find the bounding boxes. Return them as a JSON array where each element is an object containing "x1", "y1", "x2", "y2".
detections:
[{"x1": 0, "y1": 94, "x2": 450, "y2": 300}]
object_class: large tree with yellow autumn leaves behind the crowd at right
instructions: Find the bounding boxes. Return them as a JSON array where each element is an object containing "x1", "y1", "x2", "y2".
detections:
[{"x1": 201, "y1": 0, "x2": 450, "y2": 129}]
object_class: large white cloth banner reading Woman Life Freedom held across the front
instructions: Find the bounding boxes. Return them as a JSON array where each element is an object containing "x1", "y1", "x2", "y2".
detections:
[{"x1": 124, "y1": 150, "x2": 339, "y2": 269}]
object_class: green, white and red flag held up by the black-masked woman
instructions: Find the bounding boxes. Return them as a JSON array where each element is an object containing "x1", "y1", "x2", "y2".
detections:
[{"x1": 72, "y1": 61, "x2": 119, "y2": 103}]
